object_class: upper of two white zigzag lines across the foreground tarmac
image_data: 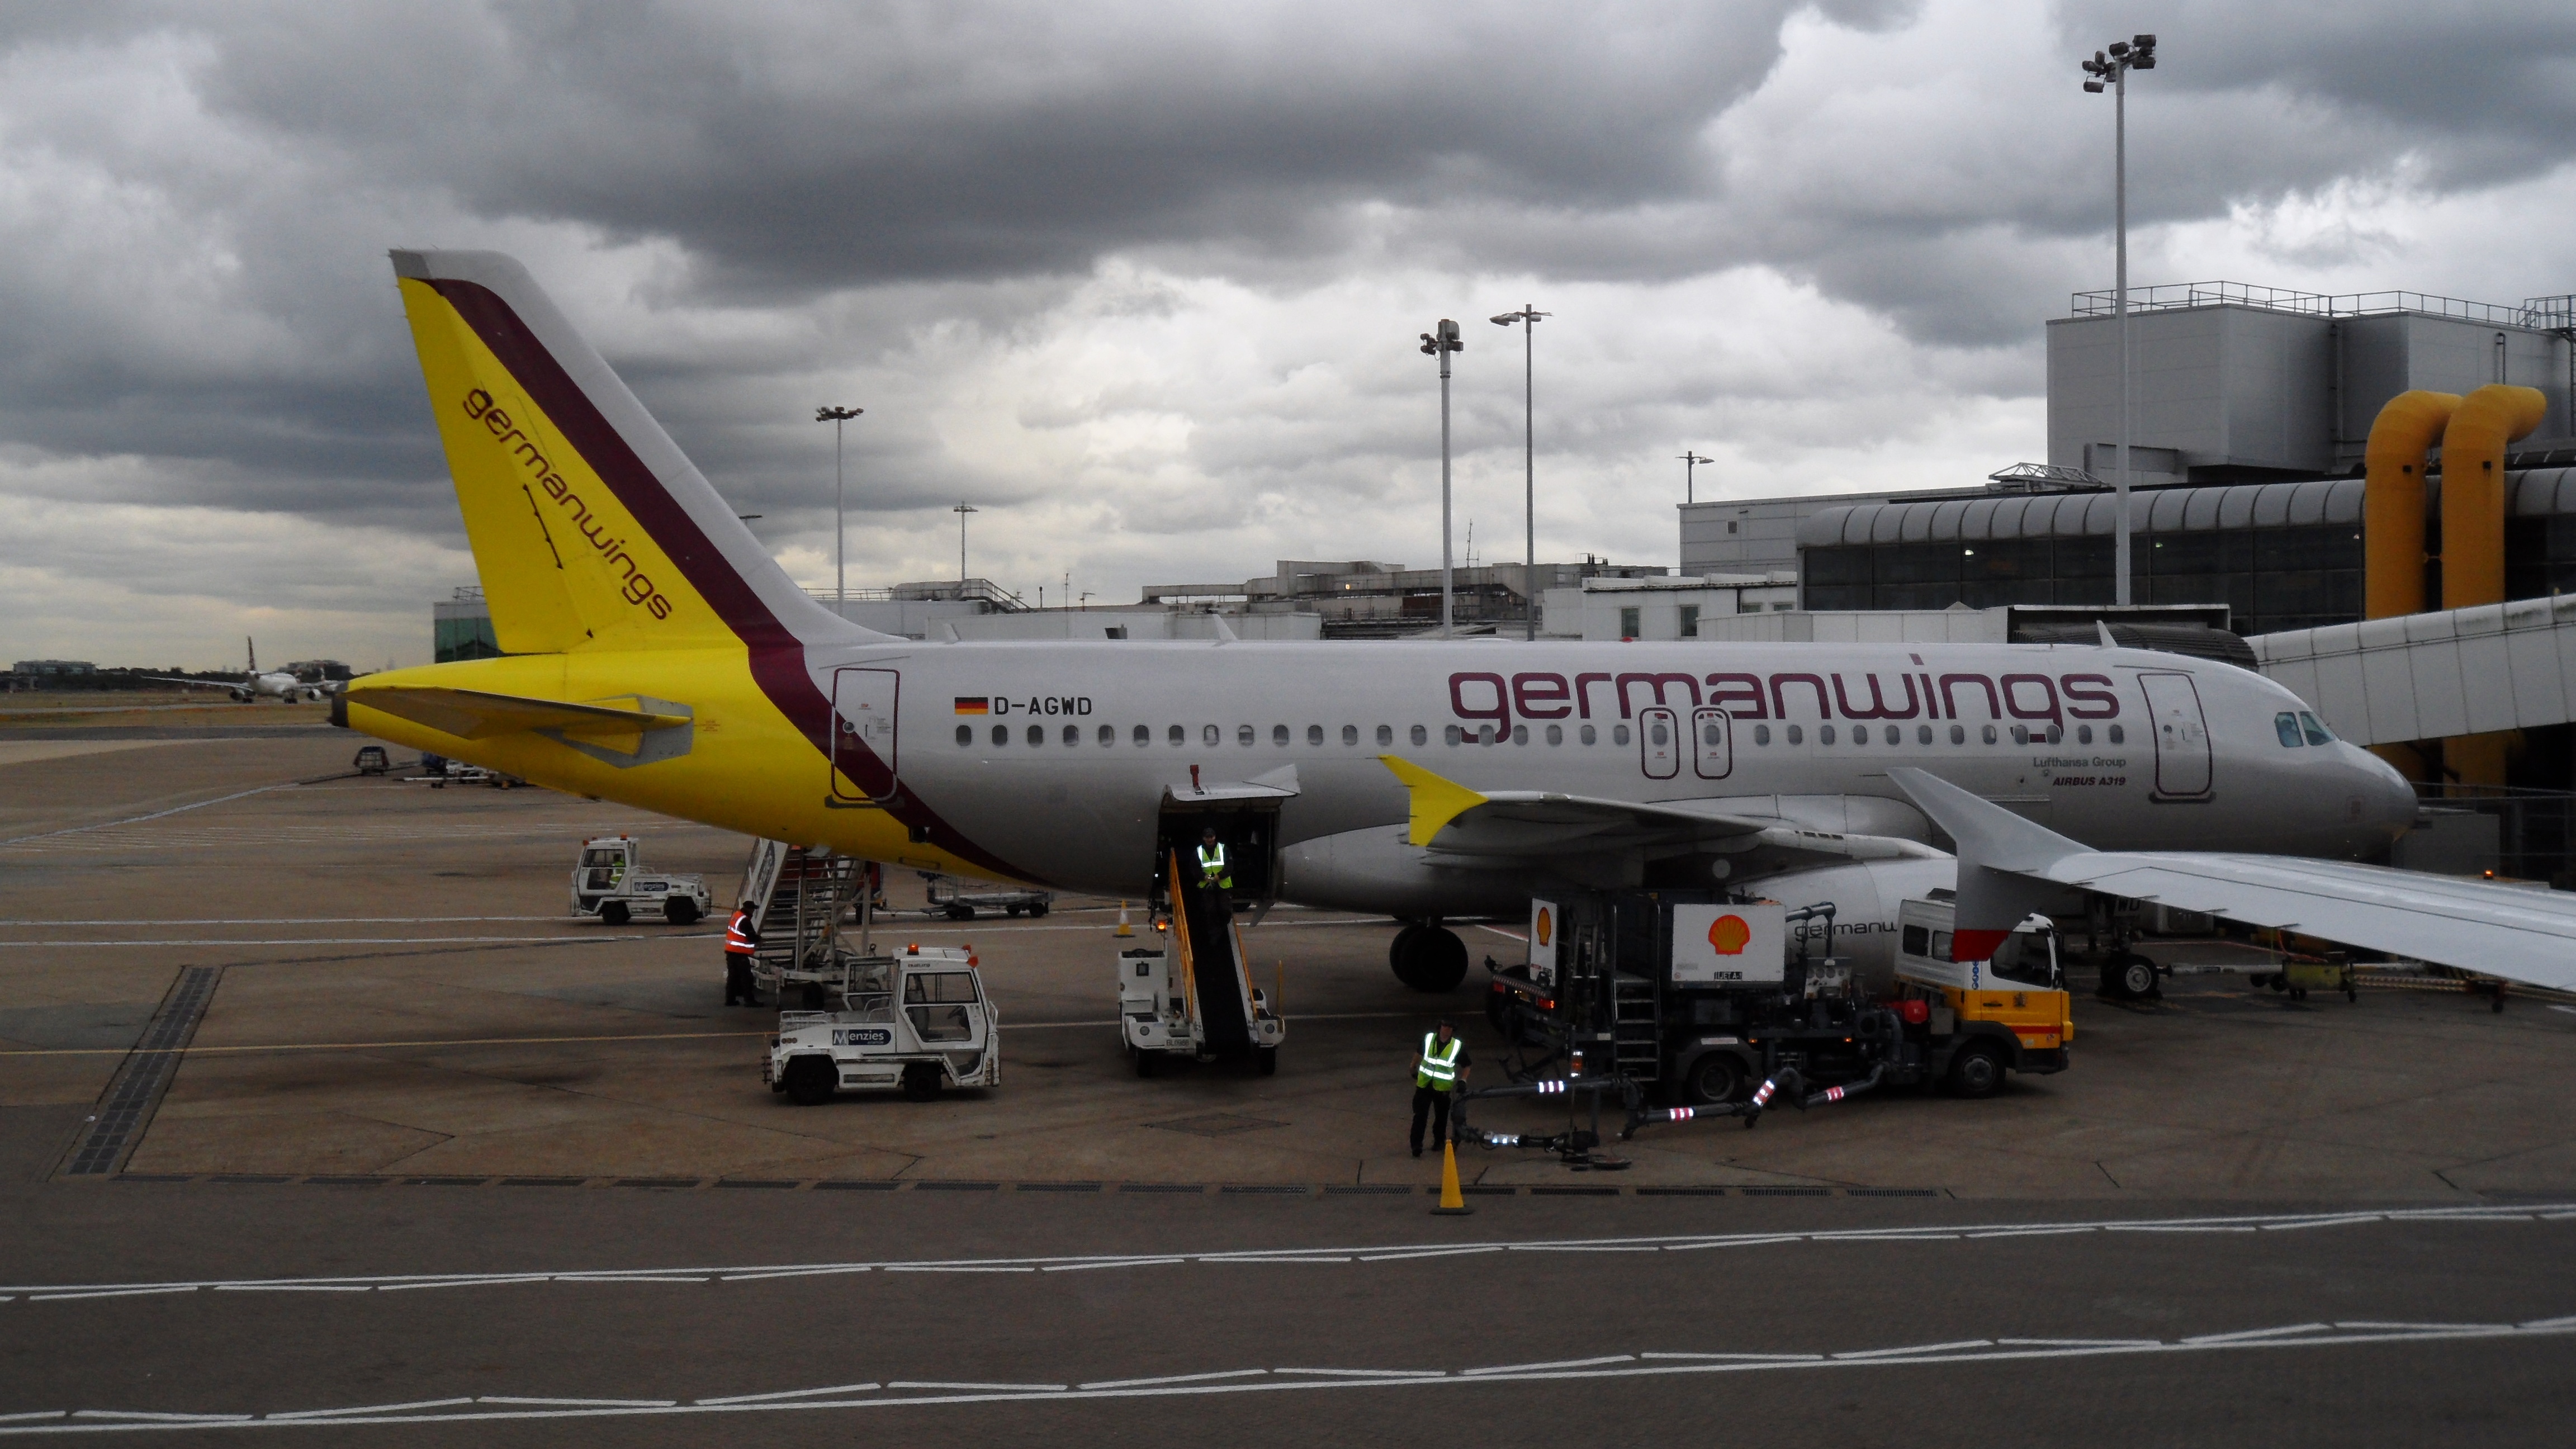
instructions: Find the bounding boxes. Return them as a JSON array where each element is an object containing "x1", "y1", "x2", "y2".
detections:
[{"x1": 0, "y1": 1209, "x2": 2576, "y2": 1299}]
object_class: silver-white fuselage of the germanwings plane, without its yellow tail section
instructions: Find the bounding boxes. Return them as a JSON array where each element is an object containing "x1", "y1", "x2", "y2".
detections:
[{"x1": 783, "y1": 631, "x2": 2416, "y2": 915}]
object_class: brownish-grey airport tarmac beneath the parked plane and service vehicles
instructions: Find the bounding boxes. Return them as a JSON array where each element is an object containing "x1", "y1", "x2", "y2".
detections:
[{"x1": 0, "y1": 707, "x2": 2576, "y2": 1446}]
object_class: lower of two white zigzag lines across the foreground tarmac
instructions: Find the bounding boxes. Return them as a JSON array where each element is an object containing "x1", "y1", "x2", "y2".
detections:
[{"x1": 20, "y1": 1315, "x2": 2576, "y2": 1439}]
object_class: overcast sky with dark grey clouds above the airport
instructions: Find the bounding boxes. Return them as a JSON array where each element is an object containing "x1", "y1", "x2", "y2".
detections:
[{"x1": 0, "y1": 0, "x2": 2576, "y2": 665}]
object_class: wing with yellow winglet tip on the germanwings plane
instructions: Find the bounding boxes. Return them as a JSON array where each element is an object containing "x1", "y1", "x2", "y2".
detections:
[{"x1": 1378, "y1": 755, "x2": 1940, "y2": 874}]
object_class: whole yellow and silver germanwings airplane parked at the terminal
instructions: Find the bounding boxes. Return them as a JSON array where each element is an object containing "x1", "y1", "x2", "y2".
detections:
[{"x1": 332, "y1": 250, "x2": 2576, "y2": 990}]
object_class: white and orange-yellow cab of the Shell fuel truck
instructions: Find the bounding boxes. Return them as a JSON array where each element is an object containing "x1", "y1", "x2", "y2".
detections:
[{"x1": 1896, "y1": 889, "x2": 2076, "y2": 1096}]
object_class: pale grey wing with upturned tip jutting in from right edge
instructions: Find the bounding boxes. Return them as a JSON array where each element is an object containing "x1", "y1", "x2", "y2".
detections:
[{"x1": 1888, "y1": 768, "x2": 2576, "y2": 990}]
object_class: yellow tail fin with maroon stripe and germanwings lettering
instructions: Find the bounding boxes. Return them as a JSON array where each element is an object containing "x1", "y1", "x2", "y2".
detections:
[{"x1": 391, "y1": 250, "x2": 884, "y2": 655}]
